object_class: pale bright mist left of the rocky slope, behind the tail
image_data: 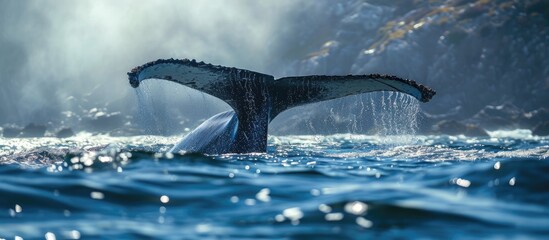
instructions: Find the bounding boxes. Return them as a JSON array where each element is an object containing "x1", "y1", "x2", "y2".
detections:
[{"x1": 0, "y1": 0, "x2": 324, "y2": 125}]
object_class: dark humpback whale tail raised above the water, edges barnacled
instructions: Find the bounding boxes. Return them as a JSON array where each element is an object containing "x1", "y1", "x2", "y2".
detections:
[{"x1": 128, "y1": 59, "x2": 435, "y2": 154}]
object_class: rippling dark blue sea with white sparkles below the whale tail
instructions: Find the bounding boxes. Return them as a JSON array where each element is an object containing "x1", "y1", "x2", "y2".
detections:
[{"x1": 0, "y1": 131, "x2": 549, "y2": 239}]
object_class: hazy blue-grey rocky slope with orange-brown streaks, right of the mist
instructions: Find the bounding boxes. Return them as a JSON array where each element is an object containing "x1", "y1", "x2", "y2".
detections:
[{"x1": 274, "y1": 0, "x2": 549, "y2": 135}]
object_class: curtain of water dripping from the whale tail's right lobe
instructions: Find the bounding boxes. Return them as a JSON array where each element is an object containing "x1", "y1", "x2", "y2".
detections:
[{"x1": 307, "y1": 92, "x2": 419, "y2": 144}]
